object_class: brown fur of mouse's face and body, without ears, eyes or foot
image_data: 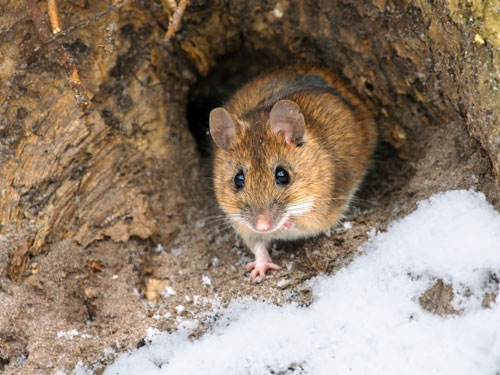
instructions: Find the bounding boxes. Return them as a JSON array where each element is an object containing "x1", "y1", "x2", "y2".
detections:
[{"x1": 209, "y1": 66, "x2": 377, "y2": 274}]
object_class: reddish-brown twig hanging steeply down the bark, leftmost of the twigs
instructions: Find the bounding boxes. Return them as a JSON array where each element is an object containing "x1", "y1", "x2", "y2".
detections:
[{"x1": 26, "y1": 0, "x2": 90, "y2": 108}]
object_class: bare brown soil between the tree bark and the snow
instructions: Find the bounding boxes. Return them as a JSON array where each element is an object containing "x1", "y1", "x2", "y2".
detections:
[{"x1": 0, "y1": 97, "x2": 500, "y2": 374}]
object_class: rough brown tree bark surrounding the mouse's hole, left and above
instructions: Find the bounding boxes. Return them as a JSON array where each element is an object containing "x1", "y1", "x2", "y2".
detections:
[{"x1": 0, "y1": 0, "x2": 500, "y2": 279}]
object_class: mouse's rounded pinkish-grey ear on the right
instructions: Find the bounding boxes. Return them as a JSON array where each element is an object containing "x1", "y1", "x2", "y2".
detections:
[{"x1": 269, "y1": 99, "x2": 306, "y2": 145}]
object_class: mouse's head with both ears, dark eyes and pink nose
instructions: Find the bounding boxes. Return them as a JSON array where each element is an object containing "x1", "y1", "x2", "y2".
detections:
[{"x1": 210, "y1": 100, "x2": 330, "y2": 233}]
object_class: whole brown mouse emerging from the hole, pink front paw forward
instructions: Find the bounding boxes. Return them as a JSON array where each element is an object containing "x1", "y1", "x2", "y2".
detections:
[{"x1": 210, "y1": 66, "x2": 377, "y2": 280}]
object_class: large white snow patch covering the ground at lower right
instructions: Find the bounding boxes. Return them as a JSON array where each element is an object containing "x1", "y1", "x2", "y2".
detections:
[{"x1": 104, "y1": 190, "x2": 500, "y2": 375}]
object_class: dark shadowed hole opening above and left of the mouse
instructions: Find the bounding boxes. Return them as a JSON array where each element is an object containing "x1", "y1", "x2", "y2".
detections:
[{"x1": 187, "y1": 50, "x2": 279, "y2": 157}]
